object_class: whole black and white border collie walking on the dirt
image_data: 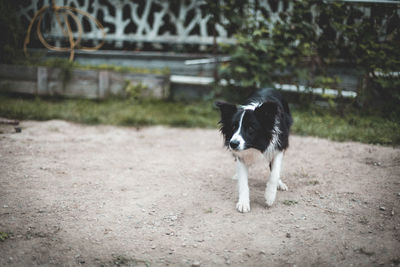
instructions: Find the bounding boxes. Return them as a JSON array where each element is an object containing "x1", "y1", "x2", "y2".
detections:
[{"x1": 216, "y1": 89, "x2": 293, "y2": 212}]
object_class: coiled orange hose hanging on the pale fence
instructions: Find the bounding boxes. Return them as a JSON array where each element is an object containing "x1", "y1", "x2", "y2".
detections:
[{"x1": 24, "y1": 0, "x2": 106, "y2": 61}]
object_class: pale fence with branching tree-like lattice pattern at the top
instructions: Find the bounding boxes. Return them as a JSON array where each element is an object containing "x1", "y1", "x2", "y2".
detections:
[{"x1": 19, "y1": 0, "x2": 400, "y2": 49}]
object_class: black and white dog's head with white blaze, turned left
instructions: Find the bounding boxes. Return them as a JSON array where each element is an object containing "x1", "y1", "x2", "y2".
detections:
[{"x1": 216, "y1": 102, "x2": 279, "y2": 152}]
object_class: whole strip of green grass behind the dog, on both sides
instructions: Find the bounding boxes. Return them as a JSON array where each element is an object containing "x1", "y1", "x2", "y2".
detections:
[{"x1": 0, "y1": 94, "x2": 400, "y2": 146}]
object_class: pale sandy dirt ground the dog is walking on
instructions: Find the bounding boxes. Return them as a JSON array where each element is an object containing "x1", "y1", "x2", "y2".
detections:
[{"x1": 0, "y1": 121, "x2": 400, "y2": 266}]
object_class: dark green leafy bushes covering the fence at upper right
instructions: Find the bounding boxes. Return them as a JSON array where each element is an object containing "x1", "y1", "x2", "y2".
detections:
[{"x1": 212, "y1": 0, "x2": 400, "y2": 111}]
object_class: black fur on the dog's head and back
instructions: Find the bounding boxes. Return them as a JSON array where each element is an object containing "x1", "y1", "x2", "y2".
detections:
[{"x1": 216, "y1": 89, "x2": 293, "y2": 153}]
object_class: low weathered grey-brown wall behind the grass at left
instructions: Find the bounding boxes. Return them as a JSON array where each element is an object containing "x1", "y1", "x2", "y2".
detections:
[{"x1": 0, "y1": 64, "x2": 170, "y2": 99}]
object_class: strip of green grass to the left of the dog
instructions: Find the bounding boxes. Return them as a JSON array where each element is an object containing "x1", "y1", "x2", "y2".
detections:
[{"x1": 0, "y1": 94, "x2": 218, "y2": 128}]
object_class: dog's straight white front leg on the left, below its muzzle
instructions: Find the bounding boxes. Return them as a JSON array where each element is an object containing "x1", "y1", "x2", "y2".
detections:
[{"x1": 236, "y1": 158, "x2": 250, "y2": 212}]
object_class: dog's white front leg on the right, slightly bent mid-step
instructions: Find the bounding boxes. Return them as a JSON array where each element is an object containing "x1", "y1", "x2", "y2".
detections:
[{"x1": 265, "y1": 151, "x2": 283, "y2": 207}]
